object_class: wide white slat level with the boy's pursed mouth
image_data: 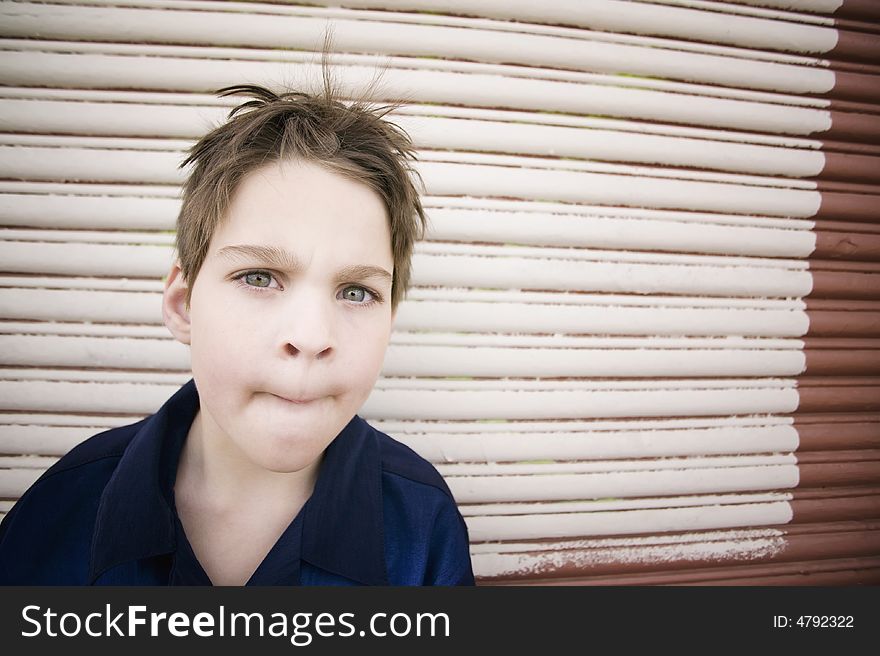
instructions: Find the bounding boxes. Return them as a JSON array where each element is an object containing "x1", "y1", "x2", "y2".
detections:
[{"x1": 0, "y1": 370, "x2": 798, "y2": 419}]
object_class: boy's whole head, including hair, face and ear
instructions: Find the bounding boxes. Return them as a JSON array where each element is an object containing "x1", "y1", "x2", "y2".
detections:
[{"x1": 163, "y1": 80, "x2": 424, "y2": 472}]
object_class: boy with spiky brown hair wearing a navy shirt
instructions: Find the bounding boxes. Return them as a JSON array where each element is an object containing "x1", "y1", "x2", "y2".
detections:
[{"x1": 0, "y1": 80, "x2": 473, "y2": 585}]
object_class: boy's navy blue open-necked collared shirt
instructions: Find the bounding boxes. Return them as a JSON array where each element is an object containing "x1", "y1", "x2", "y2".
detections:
[{"x1": 0, "y1": 380, "x2": 473, "y2": 585}]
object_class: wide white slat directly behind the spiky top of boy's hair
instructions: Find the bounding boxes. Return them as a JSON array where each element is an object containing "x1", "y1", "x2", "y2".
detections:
[{"x1": 0, "y1": 99, "x2": 825, "y2": 177}]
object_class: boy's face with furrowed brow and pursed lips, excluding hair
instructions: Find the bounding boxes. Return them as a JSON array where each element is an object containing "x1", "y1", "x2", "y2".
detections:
[{"x1": 165, "y1": 161, "x2": 394, "y2": 472}]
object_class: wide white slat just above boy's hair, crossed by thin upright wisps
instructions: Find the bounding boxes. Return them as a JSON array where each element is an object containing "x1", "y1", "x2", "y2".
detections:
[{"x1": 0, "y1": 48, "x2": 831, "y2": 136}]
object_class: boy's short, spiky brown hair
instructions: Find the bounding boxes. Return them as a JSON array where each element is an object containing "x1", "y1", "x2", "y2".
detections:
[{"x1": 176, "y1": 77, "x2": 426, "y2": 309}]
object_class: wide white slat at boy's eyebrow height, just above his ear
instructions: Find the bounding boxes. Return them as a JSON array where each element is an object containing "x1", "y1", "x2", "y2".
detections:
[{"x1": 0, "y1": 241, "x2": 813, "y2": 297}]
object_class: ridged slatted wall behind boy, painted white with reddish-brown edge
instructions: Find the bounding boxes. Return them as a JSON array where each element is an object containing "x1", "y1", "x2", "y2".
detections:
[{"x1": 0, "y1": 0, "x2": 880, "y2": 585}]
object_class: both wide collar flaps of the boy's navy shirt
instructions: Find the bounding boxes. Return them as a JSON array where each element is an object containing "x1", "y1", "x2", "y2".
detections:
[{"x1": 89, "y1": 380, "x2": 388, "y2": 585}]
